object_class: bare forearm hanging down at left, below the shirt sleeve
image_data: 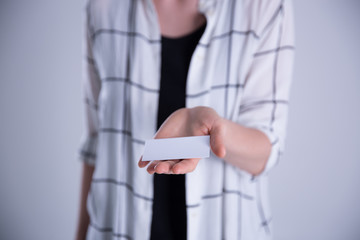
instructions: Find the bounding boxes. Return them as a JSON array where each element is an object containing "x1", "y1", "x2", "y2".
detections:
[{"x1": 75, "y1": 163, "x2": 95, "y2": 240}]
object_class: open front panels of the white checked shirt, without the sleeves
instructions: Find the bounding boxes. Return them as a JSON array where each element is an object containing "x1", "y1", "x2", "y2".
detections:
[{"x1": 84, "y1": 0, "x2": 290, "y2": 240}]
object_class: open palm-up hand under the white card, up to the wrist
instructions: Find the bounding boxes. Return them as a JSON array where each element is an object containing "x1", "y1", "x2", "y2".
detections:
[{"x1": 139, "y1": 107, "x2": 226, "y2": 174}]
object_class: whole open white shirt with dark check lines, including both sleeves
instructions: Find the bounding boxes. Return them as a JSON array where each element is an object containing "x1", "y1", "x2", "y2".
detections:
[{"x1": 80, "y1": 0, "x2": 294, "y2": 240}]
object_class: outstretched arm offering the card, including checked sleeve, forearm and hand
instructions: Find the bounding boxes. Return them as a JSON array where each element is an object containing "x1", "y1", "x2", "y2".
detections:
[{"x1": 139, "y1": 1, "x2": 294, "y2": 175}]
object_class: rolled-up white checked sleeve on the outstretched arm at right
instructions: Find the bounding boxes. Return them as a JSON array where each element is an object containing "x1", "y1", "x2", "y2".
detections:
[{"x1": 238, "y1": 0, "x2": 294, "y2": 176}]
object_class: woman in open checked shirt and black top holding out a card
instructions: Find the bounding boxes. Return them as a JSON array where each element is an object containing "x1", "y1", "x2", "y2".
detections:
[{"x1": 77, "y1": 0, "x2": 294, "y2": 239}]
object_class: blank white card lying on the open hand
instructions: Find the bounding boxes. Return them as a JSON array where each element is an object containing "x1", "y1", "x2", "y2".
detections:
[{"x1": 143, "y1": 135, "x2": 210, "y2": 161}]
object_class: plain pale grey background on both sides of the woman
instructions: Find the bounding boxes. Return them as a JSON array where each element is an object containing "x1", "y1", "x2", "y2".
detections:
[{"x1": 0, "y1": 0, "x2": 360, "y2": 240}]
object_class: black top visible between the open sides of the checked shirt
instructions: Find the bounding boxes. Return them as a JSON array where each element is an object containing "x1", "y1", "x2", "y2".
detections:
[{"x1": 151, "y1": 24, "x2": 206, "y2": 240}]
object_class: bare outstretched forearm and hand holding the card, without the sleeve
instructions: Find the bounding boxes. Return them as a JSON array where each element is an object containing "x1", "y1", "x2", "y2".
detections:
[{"x1": 139, "y1": 107, "x2": 271, "y2": 175}]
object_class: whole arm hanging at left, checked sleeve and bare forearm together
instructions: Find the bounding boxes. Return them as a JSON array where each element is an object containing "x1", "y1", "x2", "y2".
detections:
[{"x1": 75, "y1": 2, "x2": 101, "y2": 236}]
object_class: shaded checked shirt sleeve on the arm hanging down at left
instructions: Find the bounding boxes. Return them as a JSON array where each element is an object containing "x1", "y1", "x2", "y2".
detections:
[{"x1": 79, "y1": 6, "x2": 101, "y2": 165}]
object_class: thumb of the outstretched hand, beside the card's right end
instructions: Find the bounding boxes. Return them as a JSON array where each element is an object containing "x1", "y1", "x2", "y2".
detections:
[{"x1": 210, "y1": 121, "x2": 226, "y2": 158}]
